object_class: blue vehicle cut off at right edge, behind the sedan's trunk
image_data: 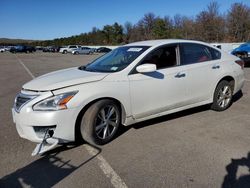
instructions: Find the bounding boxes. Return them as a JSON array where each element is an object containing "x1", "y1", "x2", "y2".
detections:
[{"x1": 231, "y1": 42, "x2": 250, "y2": 66}]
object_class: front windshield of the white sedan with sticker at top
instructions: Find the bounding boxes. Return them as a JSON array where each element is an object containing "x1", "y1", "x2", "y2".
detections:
[{"x1": 80, "y1": 46, "x2": 149, "y2": 72}]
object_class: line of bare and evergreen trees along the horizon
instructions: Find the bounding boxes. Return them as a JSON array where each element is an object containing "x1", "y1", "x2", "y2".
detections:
[{"x1": 6, "y1": 1, "x2": 250, "y2": 46}]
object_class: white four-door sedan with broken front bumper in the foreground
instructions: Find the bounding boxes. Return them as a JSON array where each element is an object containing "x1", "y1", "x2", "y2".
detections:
[{"x1": 12, "y1": 40, "x2": 244, "y2": 155}]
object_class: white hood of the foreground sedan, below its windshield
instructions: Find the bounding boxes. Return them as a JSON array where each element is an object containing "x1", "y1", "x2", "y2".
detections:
[{"x1": 23, "y1": 67, "x2": 108, "y2": 91}]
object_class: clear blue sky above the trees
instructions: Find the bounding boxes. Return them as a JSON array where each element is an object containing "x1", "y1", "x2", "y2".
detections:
[{"x1": 0, "y1": 0, "x2": 250, "y2": 40}]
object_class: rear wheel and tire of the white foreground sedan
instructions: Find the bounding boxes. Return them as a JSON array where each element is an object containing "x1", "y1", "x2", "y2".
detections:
[{"x1": 211, "y1": 80, "x2": 233, "y2": 111}]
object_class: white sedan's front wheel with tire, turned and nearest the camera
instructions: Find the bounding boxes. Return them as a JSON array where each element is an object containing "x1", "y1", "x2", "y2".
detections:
[{"x1": 80, "y1": 99, "x2": 121, "y2": 145}]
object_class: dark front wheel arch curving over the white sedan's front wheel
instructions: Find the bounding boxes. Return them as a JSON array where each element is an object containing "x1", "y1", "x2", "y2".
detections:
[{"x1": 75, "y1": 97, "x2": 126, "y2": 141}]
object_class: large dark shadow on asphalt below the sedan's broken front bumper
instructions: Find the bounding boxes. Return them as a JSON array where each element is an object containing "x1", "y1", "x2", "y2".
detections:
[{"x1": 0, "y1": 145, "x2": 101, "y2": 188}]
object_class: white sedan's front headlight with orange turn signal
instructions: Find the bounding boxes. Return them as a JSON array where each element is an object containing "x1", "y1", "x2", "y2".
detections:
[{"x1": 33, "y1": 91, "x2": 78, "y2": 111}]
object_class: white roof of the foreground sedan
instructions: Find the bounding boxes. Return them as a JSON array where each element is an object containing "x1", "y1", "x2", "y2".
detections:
[{"x1": 125, "y1": 39, "x2": 209, "y2": 46}]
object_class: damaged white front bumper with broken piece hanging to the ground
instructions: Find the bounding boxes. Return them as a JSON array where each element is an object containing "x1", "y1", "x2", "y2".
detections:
[{"x1": 12, "y1": 105, "x2": 77, "y2": 156}]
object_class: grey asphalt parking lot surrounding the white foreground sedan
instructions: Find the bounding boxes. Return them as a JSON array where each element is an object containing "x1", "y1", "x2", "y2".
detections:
[{"x1": 0, "y1": 52, "x2": 250, "y2": 188}]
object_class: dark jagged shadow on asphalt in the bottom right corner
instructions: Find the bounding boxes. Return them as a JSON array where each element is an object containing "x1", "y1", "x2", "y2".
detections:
[{"x1": 221, "y1": 152, "x2": 250, "y2": 188}]
